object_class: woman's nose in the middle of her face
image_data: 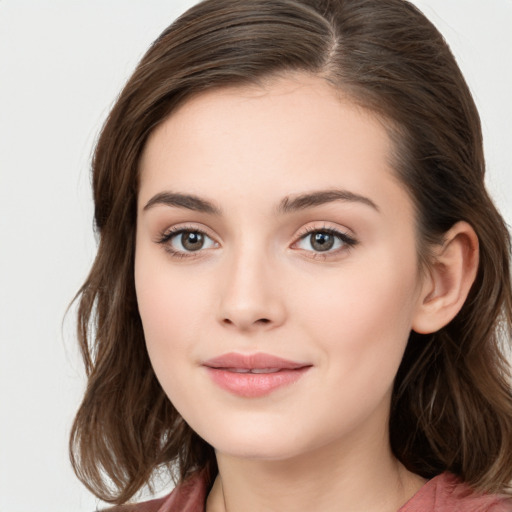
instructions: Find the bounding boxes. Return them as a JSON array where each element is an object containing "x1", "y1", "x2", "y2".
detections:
[{"x1": 218, "y1": 250, "x2": 286, "y2": 332}]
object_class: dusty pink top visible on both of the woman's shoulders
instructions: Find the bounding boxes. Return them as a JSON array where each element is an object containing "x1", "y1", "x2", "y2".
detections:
[{"x1": 110, "y1": 473, "x2": 512, "y2": 512}]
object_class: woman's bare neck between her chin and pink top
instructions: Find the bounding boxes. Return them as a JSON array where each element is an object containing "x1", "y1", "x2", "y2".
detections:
[{"x1": 207, "y1": 428, "x2": 425, "y2": 512}]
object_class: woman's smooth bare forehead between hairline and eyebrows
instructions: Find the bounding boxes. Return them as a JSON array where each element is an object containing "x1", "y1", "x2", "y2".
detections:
[{"x1": 140, "y1": 74, "x2": 408, "y2": 219}]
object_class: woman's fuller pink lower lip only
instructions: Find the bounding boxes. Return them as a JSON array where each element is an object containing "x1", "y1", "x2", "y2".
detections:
[{"x1": 207, "y1": 366, "x2": 311, "y2": 398}]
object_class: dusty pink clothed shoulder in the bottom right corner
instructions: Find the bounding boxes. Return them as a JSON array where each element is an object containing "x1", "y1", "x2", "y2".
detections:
[{"x1": 398, "y1": 473, "x2": 512, "y2": 512}]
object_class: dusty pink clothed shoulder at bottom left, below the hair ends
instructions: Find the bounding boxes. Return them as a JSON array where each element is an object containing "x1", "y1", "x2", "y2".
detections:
[{"x1": 102, "y1": 472, "x2": 207, "y2": 512}]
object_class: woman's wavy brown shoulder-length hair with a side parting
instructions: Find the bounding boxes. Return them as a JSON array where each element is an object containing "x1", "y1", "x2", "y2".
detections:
[{"x1": 70, "y1": 0, "x2": 512, "y2": 503}]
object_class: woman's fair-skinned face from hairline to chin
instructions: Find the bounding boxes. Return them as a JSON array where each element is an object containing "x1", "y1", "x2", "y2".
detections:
[{"x1": 135, "y1": 75, "x2": 425, "y2": 459}]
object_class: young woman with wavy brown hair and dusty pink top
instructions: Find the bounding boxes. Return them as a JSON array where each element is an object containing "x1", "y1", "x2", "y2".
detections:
[{"x1": 71, "y1": 0, "x2": 512, "y2": 512}]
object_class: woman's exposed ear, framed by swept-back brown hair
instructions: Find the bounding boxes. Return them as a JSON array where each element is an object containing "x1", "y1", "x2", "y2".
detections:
[{"x1": 412, "y1": 221, "x2": 478, "y2": 334}]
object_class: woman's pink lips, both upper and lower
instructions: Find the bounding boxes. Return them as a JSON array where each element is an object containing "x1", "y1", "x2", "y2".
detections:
[{"x1": 203, "y1": 353, "x2": 311, "y2": 398}]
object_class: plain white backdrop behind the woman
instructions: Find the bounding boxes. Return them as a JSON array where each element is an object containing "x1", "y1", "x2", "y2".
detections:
[{"x1": 0, "y1": 0, "x2": 512, "y2": 512}]
